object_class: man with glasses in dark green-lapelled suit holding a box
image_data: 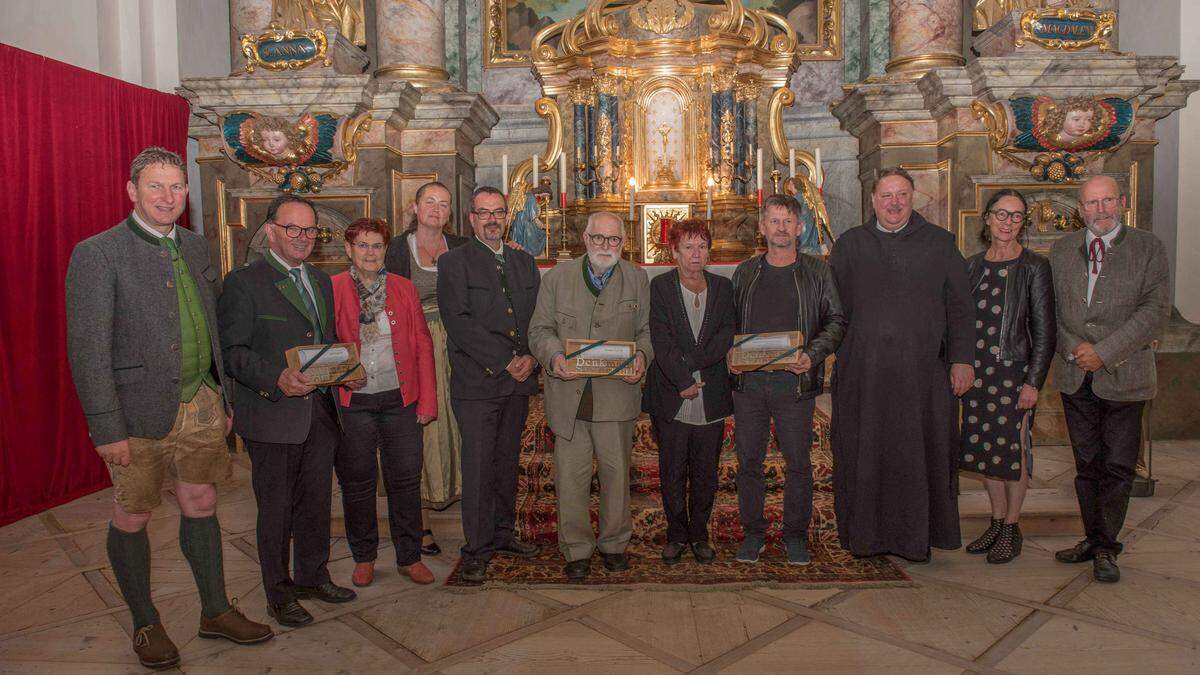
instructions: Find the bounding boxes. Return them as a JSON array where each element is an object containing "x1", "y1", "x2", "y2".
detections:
[{"x1": 217, "y1": 195, "x2": 355, "y2": 626}]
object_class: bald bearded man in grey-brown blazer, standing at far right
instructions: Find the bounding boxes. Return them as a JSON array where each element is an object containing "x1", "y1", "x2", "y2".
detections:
[{"x1": 1050, "y1": 175, "x2": 1170, "y2": 583}]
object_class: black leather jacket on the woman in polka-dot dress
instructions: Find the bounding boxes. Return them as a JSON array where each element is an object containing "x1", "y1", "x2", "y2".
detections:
[{"x1": 967, "y1": 249, "x2": 1058, "y2": 389}]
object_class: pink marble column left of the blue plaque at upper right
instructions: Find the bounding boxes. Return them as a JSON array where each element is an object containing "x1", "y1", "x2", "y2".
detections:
[{"x1": 887, "y1": 0, "x2": 965, "y2": 73}]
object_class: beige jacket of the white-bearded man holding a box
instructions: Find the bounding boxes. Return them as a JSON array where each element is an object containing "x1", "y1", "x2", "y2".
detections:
[{"x1": 529, "y1": 256, "x2": 654, "y2": 438}]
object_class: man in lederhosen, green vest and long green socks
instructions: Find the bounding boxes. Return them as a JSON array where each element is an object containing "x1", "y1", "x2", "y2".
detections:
[{"x1": 66, "y1": 148, "x2": 272, "y2": 668}]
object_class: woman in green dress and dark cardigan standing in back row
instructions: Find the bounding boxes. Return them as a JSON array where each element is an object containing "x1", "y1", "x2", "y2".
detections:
[{"x1": 385, "y1": 181, "x2": 467, "y2": 555}]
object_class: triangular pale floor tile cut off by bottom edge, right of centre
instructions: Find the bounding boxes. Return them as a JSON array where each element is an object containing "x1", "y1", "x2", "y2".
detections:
[{"x1": 722, "y1": 621, "x2": 962, "y2": 675}]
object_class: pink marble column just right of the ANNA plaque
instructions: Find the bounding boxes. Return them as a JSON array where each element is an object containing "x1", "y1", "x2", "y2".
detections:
[{"x1": 376, "y1": 0, "x2": 449, "y2": 86}]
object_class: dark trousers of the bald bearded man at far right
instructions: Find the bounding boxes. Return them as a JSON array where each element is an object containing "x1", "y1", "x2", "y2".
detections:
[{"x1": 1062, "y1": 374, "x2": 1146, "y2": 554}]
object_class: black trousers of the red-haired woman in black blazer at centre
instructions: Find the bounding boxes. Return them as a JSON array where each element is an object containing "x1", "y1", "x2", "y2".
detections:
[{"x1": 650, "y1": 416, "x2": 725, "y2": 544}]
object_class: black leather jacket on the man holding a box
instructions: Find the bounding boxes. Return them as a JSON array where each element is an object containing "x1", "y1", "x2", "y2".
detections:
[{"x1": 733, "y1": 253, "x2": 846, "y2": 399}]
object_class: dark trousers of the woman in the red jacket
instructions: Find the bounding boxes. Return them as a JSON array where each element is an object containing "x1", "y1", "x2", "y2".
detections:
[{"x1": 334, "y1": 389, "x2": 424, "y2": 567}]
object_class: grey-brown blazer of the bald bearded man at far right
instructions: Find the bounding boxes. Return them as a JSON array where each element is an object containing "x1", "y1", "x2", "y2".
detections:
[{"x1": 1050, "y1": 226, "x2": 1171, "y2": 401}]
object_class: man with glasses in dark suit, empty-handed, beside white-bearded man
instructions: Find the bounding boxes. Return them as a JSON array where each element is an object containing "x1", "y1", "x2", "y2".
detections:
[{"x1": 438, "y1": 186, "x2": 541, "y2": 581}]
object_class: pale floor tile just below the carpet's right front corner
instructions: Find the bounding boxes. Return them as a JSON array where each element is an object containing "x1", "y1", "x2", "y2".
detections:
[{"x1": 827, "y1": 584, "x2": 1031, "y2": 658}]
